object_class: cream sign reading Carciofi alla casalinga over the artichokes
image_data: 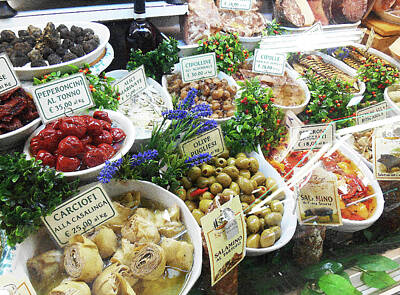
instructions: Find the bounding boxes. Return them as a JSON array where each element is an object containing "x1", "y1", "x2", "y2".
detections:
[{"x1": 42, "y1": 184, "x2": 118, "y2": 247}]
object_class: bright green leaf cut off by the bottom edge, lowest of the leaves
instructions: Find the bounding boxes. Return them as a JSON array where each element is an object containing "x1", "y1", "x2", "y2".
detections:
[{"x1": 318, "y1": 274, "x2": 362, "y2": 295}]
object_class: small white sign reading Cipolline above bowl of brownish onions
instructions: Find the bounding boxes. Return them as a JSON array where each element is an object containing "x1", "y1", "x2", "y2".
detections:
[{"x1": 179, "y1": 52, "x2": 217, "y2": 83}]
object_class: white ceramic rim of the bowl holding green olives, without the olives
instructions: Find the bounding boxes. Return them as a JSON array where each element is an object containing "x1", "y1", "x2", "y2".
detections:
[{"x1": 246, "y1": 152, "x2": 297, "y2": 256}]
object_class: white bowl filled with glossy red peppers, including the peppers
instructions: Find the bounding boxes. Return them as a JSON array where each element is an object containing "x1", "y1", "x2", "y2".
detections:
[{"x1": 24, "y1": 110, "x2": 135, "y2": 181}]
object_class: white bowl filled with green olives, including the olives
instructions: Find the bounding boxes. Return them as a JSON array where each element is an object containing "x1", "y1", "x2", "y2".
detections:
[{"x1": 176, "y1": 152, "x2": 297, "y2": 256}]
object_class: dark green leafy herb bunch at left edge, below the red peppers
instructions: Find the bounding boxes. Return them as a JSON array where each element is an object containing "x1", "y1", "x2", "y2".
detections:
[{"x1": 0, "y1": 153, "x2": 79, "y2": 247}]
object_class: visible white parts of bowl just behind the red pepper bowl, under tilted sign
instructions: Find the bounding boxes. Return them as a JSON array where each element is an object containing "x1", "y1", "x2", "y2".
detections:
[{"x1": 106, "y1": 70, "x2": 174, "y2": 145}]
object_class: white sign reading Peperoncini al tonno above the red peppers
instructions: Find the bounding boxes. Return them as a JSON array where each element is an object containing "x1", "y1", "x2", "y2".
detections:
[{"x1": 32, "y1": 73, "x2": 95, "y2": 123}]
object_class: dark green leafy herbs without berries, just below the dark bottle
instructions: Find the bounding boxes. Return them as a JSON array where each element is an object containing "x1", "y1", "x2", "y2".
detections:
[{"x1": 126, "y1": 38, "x2": 179, "y2": 82}]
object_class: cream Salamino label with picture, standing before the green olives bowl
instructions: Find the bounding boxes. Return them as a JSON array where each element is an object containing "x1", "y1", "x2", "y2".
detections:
[{"x1": 200, "y1": 196, "x2": 246, "y2": 286}]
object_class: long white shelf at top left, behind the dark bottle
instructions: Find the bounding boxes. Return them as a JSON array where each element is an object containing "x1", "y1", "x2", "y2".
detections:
[{"x1": 0, "y1": 1, "x2": 188, "y2": 29}]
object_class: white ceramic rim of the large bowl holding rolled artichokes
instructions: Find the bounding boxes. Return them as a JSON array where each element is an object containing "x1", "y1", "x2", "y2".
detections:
[{"x1": 13, "y1": 180, "x2": 203, "y2": 295}]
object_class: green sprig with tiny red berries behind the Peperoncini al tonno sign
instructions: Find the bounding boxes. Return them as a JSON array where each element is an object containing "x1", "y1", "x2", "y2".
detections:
[{"x1": 33, "y1": 64, "x2": 120, "y2": 111}]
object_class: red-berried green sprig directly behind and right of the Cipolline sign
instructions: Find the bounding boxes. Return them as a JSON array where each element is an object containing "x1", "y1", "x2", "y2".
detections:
[{"x1": 197, "y1": 33, "x2": 250, "y2": 75}]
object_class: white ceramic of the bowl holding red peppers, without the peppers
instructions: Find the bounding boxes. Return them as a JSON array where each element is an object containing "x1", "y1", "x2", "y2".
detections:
[{"x1": 24, "y1": 110, "x2": 136, "y2": 181}]
